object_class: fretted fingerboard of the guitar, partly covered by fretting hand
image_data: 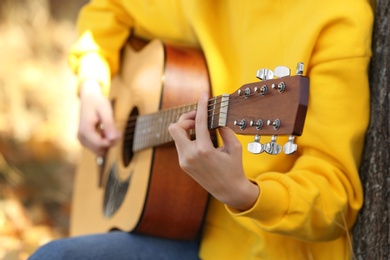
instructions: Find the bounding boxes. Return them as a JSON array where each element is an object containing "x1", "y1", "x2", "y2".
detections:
[{"x1": 133, "y1": 94, "x2": 230, "y2": 152}]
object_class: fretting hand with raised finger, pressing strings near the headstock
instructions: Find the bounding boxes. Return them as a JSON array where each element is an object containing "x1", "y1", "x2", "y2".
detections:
[{"x1": 169, "y1": 91, "x2": 260, "y2": 210}]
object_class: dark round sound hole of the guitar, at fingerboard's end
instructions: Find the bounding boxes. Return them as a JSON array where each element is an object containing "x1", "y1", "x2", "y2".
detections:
[{"x1": 122, "y1": 107, "x2": 138, "y2": 167}]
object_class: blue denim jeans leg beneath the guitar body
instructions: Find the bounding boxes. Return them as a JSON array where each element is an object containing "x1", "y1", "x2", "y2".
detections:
[{"x1": 29, "y1": 231, "x2": 199, "y2": 260}]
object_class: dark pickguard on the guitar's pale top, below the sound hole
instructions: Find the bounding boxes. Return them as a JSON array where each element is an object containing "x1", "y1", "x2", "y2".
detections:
[{"x1": 103, "y1": 163, "x2": 131, "y2": 218}]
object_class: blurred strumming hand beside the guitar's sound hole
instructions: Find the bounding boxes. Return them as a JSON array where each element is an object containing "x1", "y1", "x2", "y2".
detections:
[{"x1": 77, "y1": 80, "x2": 120, "y2": 156}]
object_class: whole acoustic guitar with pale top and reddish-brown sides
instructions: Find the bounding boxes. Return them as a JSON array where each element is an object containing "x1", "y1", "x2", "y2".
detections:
[{"x1": 71, "y1": 40, "x2": 309, "y2": 240}]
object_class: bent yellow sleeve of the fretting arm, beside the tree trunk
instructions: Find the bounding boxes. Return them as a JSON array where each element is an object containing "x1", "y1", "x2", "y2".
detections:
[{"x1": 228, "y1": 1, "x2": 373, "y2": 241}]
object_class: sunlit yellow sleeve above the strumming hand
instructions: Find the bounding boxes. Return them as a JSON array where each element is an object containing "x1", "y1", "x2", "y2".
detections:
[{"x1": 69, "y1": 0, "x2": 133, "y2": 95}]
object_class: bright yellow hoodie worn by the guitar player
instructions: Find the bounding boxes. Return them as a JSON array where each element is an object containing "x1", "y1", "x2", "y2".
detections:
[{"x1": 69, "y1": 0, "x2": 373, "y2": 259}]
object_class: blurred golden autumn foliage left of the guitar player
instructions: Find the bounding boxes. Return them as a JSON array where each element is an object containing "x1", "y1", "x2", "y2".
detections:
[{"x1": 0, "y1": 0, "x2": 88, "y2": 259}]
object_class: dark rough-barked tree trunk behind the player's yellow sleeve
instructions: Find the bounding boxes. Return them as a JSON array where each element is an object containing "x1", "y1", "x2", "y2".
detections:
[{"x1": 352, "y1": 0, "x2": 390, "y2": 260}]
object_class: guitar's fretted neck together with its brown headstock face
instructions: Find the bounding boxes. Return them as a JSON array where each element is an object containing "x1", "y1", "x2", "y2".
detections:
[{"x1": 130, "y1": 76, "x2": 309, "y2": 152}]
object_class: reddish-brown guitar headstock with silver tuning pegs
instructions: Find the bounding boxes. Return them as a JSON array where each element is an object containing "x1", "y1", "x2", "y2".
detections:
[{"x1": 209, "y1": 63, "x2": 309, "y2": 154}]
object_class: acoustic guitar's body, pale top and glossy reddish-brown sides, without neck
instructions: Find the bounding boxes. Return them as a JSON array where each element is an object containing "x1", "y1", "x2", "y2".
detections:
[{"x1": 71, "y1": 40, "x2": 210, "y2": 240}]
